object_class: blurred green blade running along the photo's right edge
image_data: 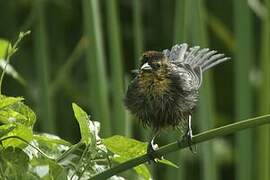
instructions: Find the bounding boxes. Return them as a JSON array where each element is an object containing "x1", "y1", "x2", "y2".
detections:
[{"x1": 256, "y1": 0, "x2": 270, "y2": 180}]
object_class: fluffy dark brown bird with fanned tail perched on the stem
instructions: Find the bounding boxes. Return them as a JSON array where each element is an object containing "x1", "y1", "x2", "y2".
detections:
[{"x1": 124, "y1": 43, "x2": 230, "y2": 158}]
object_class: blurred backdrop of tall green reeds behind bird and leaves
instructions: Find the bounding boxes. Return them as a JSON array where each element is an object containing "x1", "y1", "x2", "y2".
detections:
[{"x1": 0, "y1": 0, "x2": 270, "y2": 180}]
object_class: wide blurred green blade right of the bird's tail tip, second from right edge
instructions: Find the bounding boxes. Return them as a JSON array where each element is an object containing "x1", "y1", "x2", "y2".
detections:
[{"x1": 233, "y1": 0, "x2": 254, "y2": 180}]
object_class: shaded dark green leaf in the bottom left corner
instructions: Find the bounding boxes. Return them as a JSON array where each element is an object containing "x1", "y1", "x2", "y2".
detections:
[{"x1": 0, "y1": 147, "x2": 29, "y2": 179}]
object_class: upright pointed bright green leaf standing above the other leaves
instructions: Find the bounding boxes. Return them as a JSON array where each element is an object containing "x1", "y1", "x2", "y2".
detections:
[{"x1": 72, "y1": 103, "x2": 94, "y2": 145}]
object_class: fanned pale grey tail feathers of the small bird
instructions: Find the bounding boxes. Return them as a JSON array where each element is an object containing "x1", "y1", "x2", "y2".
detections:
[{"x1": 164, "y1": 43, "x2": 230, "y2": 71}]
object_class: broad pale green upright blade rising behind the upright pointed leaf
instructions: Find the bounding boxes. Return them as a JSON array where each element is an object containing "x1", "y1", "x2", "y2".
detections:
[{"x1": 82, "y1": 0, "x2": 111, "y2": 137}]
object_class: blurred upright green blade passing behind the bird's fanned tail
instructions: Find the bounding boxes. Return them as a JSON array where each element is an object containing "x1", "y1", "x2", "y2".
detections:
[{"x1": 190, "y1": 0, "x2": 218, "y2": 180}]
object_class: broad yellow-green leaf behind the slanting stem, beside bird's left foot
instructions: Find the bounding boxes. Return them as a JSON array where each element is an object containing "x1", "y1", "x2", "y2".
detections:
[{"x1": 103, "y1": 135, "x2": 151, "y2": 179}]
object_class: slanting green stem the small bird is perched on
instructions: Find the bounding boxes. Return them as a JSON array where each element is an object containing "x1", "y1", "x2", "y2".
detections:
[{"x1": 91, "y1": 114, "x2": 270, "y2": 180}]
